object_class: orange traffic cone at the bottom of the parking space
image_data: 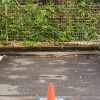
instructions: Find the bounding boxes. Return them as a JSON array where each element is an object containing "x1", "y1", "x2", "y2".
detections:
[{"x1": 47, "y1": 83, "x2": 55, "y2": 100}]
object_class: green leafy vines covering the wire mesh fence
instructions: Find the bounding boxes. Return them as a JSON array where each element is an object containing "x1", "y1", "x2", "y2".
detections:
[{"x1": 0, "y1": 1, "x2": 100, "y2": 44}]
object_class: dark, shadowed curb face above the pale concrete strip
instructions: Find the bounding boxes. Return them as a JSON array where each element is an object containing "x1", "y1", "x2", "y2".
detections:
[{"x1": 0, "y1": 46, "x2": 100, "y2": 52}]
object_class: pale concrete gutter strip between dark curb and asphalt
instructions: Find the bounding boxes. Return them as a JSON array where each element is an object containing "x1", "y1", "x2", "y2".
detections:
[{"x1": 0, "y1": 51, "x2": 100, "y2": 56}]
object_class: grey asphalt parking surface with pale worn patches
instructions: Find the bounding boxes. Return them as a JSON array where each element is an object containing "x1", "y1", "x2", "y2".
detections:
[{"x1": 0, "y1": 55, "x2": 100, "y2": 100}]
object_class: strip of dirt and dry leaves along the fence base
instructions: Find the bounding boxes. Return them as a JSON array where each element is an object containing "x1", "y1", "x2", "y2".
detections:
[{"x1": 0, "y1": 40, "x2": 100, "y2": 47}]
